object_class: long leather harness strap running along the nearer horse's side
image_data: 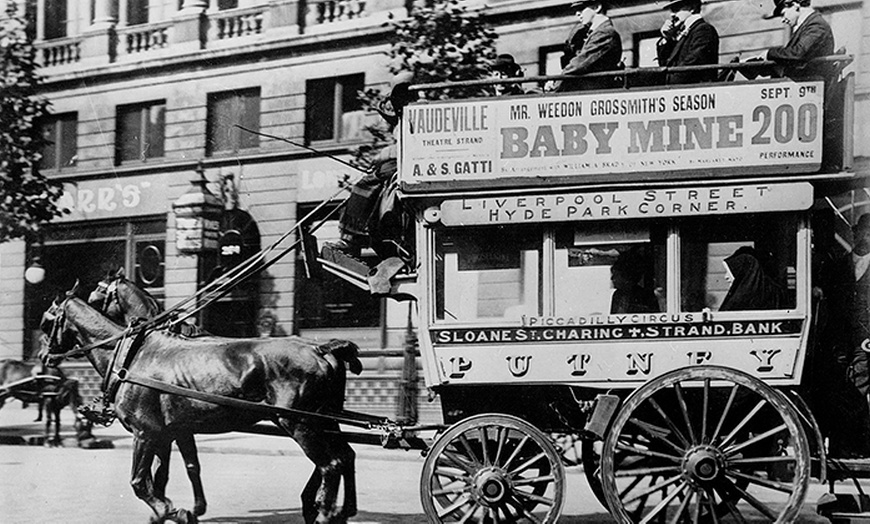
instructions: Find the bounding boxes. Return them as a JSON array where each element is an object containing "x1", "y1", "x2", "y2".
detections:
[{"x1": 121, "y1": 373, "x2": 387, "y2": 429}]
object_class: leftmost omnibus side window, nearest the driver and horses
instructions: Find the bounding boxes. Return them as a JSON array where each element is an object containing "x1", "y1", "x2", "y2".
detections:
[{"x1": 435, "y1": 227, "x2": 542, "y2": 322}]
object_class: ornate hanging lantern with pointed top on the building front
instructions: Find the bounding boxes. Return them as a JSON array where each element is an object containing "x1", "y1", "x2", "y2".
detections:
[{"x1": 172, "y1": 161, "x2": 223, "y2": 255}]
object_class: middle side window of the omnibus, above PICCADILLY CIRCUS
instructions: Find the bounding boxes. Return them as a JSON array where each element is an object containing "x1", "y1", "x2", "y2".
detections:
[{"x1": 553, "y1": 221, "x2": 666, "y2": 317}]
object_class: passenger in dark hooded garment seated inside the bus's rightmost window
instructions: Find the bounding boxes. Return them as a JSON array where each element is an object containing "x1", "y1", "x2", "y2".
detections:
[{"x1": 719, "y1": 246, "x2": 785, "y2": 311}]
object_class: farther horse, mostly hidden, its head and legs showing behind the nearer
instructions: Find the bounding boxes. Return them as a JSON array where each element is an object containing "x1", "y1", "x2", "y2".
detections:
[{"x1": 88, "y1": 270, "x2": 208, "y2": 516}]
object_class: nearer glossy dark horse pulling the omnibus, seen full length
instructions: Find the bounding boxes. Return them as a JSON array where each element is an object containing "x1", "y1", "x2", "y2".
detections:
[{"x1": 41, "y1": 293, "x2": 362, "y2": 523}]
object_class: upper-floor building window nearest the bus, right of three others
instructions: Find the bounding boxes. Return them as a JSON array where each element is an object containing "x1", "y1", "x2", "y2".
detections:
[{"x1": 305, "y1": 74, "x2": 365, "y2": 143}]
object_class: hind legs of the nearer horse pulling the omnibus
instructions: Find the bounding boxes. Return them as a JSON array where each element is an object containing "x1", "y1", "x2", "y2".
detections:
[{"x1": 278, "y1": 418, "x2": 346, "y2": 524}]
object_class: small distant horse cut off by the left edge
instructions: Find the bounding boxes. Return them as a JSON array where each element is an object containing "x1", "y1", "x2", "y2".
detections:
[{"x1": 0, "y1": 360, "x2": 81, "y2": 445}]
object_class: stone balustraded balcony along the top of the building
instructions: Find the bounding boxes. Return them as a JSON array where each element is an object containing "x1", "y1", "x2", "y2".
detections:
[{"x1": 29, "y1": 0, "x2": 411, "y2": 75}]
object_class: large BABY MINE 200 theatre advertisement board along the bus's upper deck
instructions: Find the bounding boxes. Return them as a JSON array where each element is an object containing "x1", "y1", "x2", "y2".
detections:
[{"x1": 400, "y1": 80, "x2": 824, "y2": 186}]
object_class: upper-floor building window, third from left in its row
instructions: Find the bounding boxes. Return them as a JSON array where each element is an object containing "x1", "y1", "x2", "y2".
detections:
[{"x1": 206, "y1": 87, "x2": 260, "y2": 155}]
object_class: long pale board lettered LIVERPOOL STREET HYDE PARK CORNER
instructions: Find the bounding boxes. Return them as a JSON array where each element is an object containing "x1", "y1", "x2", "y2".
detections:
[{"x1": 441, "y1": 182, "x2": 813, "y2": 226}]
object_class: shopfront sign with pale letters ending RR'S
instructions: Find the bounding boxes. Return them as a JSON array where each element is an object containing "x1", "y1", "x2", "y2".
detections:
[{"x1": 56, "y1": 173, "x2": 173, "y2": 222}]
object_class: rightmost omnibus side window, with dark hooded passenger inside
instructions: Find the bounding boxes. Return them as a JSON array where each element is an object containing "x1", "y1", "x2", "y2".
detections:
[{"x1": 680, "y1": 214, "x2": 798, "y2": 311}]
